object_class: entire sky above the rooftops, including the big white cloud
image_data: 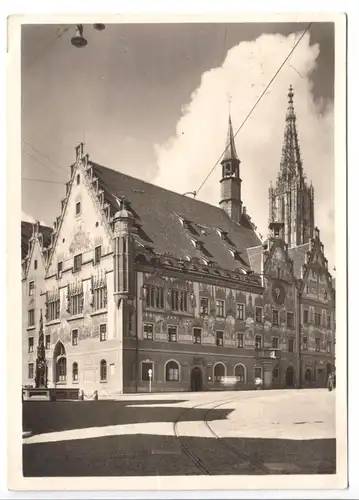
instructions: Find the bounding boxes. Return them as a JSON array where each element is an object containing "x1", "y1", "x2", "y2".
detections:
[{"x1": 21, "y1": 23, "x2": 335, "y2": 270}]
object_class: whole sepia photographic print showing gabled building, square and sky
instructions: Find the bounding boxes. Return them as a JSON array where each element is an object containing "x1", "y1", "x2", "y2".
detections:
[{"x1": 9, "y1": 15, "x2": 347, "y2": 489}]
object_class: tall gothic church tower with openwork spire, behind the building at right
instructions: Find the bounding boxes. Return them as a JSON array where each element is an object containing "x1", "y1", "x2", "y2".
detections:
[{"x1": 269, "y1": 86, "x2": 314, "y2": 248}]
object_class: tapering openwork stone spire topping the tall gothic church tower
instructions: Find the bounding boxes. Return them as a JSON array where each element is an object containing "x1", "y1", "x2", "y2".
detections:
[{"x1": 280, "y1": 85, "x2": 302, "y2": 181}]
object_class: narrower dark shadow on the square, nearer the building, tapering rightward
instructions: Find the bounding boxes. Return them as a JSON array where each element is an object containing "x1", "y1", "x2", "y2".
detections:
[{"x1": 23, "y1": 400, "x2": 233, "y2": 435}]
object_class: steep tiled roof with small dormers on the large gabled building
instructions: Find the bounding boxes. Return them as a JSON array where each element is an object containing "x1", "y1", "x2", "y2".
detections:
[{"x1": 89, "y1": 161, "x2": 260, "y2": 270}]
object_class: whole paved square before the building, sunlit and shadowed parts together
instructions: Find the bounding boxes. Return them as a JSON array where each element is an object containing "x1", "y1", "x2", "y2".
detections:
[{"x1": 23, "y1": 389, "x2": 336, "y2": 476}]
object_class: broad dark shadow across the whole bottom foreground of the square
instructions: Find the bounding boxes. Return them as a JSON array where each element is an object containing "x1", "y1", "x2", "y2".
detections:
[{"x1": 23, "y1": 434, "x2": 336, "y2": 477}]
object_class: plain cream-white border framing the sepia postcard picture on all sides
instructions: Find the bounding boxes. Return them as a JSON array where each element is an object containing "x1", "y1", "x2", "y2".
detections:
[{"x1": 7, "y1": 12, "x2": 347, "y2": 492}]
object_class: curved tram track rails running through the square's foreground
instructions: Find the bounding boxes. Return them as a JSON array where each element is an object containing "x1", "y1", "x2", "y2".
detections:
[{"x1": 173, "y1": 396, "x2": 271, "y2": 475}]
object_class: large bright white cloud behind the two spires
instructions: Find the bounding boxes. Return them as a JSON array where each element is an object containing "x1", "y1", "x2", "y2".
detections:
[{"x1": 155, "y1": 33, "x2": 334, "y2": 268}]
